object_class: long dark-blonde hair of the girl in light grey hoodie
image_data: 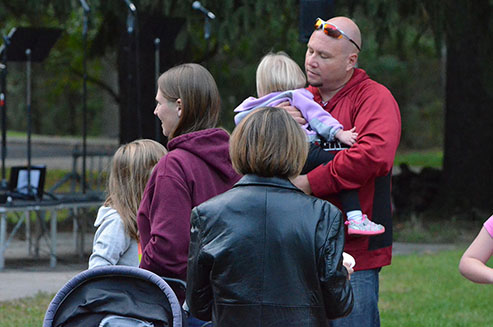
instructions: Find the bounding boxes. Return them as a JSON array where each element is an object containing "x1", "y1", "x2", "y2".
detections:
[{"x1": 104, "y1": 139, "x2": 168, "y2": 241}]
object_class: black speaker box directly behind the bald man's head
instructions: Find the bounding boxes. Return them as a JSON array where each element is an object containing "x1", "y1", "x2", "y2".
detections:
[{"x1": 300, "y1": 0, "x2": 334, "y2": 43}]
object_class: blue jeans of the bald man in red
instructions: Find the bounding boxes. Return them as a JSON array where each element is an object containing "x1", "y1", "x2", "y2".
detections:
[{"x1": 329, "y1": 268, "x2": 380, "y2": 327}]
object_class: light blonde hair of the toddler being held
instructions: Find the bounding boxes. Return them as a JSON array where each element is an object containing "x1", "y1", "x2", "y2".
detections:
[{"x1": 257, "y1": 51, "x2": 306, "y2": 97}]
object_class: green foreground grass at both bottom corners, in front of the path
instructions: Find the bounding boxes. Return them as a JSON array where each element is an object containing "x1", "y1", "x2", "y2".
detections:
[{"x1": 0, "y1": 250, "x2": 493, "y2": 327}]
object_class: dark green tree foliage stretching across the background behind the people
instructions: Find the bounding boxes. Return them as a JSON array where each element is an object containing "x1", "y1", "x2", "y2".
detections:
[{"x1": 0, "y1": 0, "x2": 444, "y2": 148}]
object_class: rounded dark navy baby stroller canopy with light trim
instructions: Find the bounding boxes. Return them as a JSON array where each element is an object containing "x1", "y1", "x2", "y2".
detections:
[{"x1": 43, "y1": 266, "x2": 184, "y2": 327}]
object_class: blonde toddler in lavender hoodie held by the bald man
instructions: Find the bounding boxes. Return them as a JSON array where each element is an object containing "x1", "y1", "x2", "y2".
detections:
[{"x1": 234, "y1": 52, "x2": 385, "y2": 235}]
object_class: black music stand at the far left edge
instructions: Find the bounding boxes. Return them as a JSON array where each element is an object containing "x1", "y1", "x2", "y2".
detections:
[{"x1": 0, "y1": 27, "x2": 62, "y2": 196}]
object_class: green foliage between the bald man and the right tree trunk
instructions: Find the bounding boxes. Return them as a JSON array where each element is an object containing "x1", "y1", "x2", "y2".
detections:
[{"x1": 345, "y1": 1, "x2": 445, "y2": 149}]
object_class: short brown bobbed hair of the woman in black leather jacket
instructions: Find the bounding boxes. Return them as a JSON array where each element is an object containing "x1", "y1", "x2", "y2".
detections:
[{"x1": 229, "y1": 107, "x2": 308, "y2": 178}]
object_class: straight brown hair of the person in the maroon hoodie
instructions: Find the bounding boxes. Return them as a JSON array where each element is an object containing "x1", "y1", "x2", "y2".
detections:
[{"x1": 158, "y1": 64, "x2": 221, "y2": 139}]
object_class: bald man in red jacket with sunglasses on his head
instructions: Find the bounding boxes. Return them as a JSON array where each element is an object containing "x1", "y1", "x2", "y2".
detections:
[{"x1": 285, "y1": 17, "x2": 401, "y2": 327}]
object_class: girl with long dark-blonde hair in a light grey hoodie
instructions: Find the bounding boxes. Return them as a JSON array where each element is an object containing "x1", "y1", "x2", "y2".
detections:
[{"x1": 89, "y1": 139, "x2": 167, "y2": 268}]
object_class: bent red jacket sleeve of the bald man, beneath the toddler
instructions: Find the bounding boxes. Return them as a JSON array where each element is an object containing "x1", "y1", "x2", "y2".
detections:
[{"x1": 307, "y1": 84, "x2": 401, "y2": 197}]
